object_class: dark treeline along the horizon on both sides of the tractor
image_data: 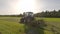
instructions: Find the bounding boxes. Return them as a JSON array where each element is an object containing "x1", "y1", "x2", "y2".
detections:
[{"x1": 0, "y1": 10, "x2": 60, "y2": 18}]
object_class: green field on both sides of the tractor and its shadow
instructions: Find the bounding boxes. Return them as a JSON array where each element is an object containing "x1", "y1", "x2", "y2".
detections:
[{"x1": 0, "y1": 17, "x2": 60, "y2": 34}]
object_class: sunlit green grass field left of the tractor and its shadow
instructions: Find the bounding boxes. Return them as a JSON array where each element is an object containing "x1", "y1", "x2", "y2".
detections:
[{"x1": 0, "y1": 17, "x2": 24, "y2": 34}]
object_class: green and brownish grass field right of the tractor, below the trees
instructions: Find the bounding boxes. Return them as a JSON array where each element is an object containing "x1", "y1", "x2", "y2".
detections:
[{"x1": 36, "y1": 18, "x2": 60, "y2": 34}]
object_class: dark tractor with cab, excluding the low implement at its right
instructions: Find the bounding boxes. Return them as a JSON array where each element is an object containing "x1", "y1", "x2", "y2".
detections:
[{"x1": 20, "y1": 12, "x2": 34, "y2": 23}]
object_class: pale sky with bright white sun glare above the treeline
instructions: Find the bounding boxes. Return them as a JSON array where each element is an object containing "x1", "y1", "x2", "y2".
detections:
[{"x1": 0, "y1": 0, "x2": 60, "y2": 15}]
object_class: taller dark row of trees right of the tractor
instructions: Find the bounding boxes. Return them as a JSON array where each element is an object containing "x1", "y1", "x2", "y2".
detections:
[{"x1": 35, "y1": 10, "x2": 60, "y2": 18}]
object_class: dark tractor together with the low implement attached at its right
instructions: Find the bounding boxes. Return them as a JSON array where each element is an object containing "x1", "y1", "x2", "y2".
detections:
[{"x1": 20, "y1": 12, "x2": 44, "y2": 27}]
